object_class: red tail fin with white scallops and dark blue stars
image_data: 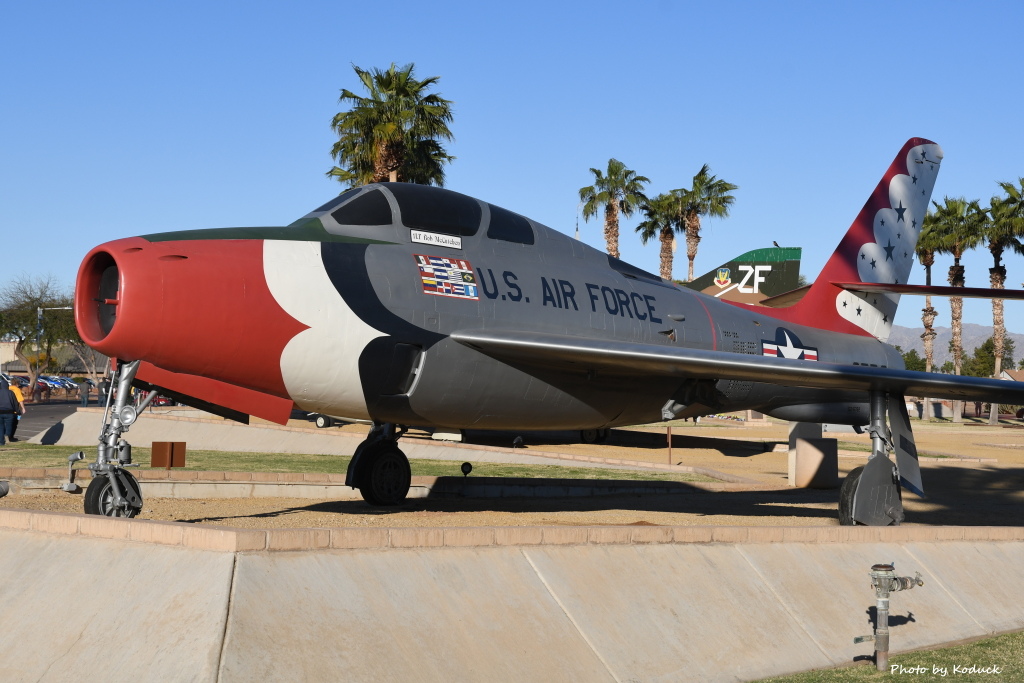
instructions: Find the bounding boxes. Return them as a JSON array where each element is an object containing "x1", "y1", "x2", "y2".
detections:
[{"x1": 768, "y1": 137, "x2": 942, "y2": 341}]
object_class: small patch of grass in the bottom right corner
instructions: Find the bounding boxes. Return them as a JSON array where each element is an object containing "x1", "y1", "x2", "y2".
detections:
[{"x1": 762, "y1": 631, "x2": 1024, "y2": 683}]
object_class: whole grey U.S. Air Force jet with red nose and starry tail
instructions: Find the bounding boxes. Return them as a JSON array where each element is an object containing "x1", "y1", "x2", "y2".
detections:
[{"x1": 71, "y1": 138, "x2": 1024, "y2": 524}]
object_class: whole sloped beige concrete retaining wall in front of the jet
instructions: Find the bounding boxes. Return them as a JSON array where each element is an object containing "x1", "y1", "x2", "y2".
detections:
[{"x1": 0, "y1": 511, "x2": 1024, "y2": 681}]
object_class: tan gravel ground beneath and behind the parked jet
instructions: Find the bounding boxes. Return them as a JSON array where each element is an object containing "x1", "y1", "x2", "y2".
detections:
[{"x1": 0, "y1": 423, "x2": 1024, "y2": 528}]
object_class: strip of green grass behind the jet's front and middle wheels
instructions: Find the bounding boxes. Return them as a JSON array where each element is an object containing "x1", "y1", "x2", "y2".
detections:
[{"x1": 0, "y1": 442, "x2": 718, "y2": 482}]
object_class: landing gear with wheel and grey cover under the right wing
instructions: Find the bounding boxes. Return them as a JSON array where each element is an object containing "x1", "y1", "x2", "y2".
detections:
[{"x1": 839, "y1": 391, "x2": 924, "y2": 526}]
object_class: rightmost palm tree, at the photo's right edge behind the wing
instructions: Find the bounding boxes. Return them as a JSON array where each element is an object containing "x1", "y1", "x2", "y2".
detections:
[{"x1": 984, "y1": 178, "x2": 1024, "y2": 425}]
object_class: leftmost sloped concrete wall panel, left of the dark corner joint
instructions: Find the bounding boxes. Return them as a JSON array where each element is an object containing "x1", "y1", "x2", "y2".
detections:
[{"x1": 0, "y1": 530, "x2": 234, "y2": 683}]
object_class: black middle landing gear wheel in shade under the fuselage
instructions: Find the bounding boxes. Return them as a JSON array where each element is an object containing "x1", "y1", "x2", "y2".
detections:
[{"x1": 345, "y1": 422, "x2": 413, "y2": 505}]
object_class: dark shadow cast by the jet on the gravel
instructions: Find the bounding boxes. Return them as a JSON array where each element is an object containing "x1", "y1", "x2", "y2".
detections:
[{"x1": 174, "y1": 467, "x2": 1024, "y2": 526}]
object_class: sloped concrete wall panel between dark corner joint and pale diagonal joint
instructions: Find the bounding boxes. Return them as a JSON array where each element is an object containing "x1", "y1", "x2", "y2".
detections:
[{"x1": 220, "y1": 548, "x2": 614, "y2": 683}]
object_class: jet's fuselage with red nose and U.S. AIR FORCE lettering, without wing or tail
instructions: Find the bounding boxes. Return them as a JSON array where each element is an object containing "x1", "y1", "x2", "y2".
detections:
[{"x1": 79, "y1": 183, "x2": 902, "y2": 429}]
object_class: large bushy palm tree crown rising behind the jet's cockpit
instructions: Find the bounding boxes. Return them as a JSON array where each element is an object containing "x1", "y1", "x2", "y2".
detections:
[{"x1": 327, "y1": 63, "x2": 455, "y2": 186}]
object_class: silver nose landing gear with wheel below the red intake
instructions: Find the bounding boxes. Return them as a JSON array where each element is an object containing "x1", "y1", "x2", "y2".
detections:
[{"x1": 60, "y1": 360, "x2": 157, "y2": 517}]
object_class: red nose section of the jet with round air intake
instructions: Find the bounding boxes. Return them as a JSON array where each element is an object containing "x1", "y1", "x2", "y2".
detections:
[{"x1": 75, "y1": 238, "x2": 305, "y2": 397}]
